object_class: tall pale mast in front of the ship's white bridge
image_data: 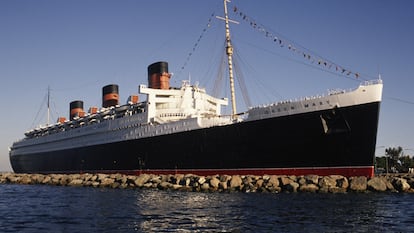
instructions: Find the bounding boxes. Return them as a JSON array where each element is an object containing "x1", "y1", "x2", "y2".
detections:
[{"x1": 223, "y1": 0, "x2": 237, "y2": 119}]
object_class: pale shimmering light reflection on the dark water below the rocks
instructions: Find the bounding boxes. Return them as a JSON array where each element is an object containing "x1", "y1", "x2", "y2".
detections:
[{"x1": 136, "y1": 190, "x2": 244, "y2": 232}]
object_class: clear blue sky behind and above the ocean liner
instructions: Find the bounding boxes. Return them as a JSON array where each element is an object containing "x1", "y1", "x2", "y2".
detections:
[{"x1": 0, "y1": 0, "x2": 414, "y2": 171}]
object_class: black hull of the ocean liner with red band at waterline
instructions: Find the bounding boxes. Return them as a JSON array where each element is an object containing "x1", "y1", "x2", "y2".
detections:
[{"x1": 10, "y1": 102, "x2": 380, "y2": 176}]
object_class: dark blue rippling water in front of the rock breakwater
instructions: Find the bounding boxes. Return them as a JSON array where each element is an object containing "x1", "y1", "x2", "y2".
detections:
[{"x1": 0, "y1": 184, "x2": 414, "y2": 233}]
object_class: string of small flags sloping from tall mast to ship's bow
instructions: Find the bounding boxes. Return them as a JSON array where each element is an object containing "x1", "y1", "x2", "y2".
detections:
[{"x1": 233, "y1": 6, "x2": 361, "y2": 79}]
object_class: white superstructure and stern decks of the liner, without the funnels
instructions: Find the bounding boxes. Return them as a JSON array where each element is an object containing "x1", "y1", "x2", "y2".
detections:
[{"x1": 13, "y1": 78, "x2": 232, "y2": 157}]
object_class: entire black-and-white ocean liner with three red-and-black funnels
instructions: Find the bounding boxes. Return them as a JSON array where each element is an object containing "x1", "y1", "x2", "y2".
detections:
[{"x1": 10, "y1": 0, "x2": 382, "y2": 177}]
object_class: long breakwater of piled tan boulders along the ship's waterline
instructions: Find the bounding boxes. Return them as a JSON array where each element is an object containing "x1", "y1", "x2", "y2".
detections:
[{"x1": 0, "y1": 173, "x2": 414, "y2": 193}]
